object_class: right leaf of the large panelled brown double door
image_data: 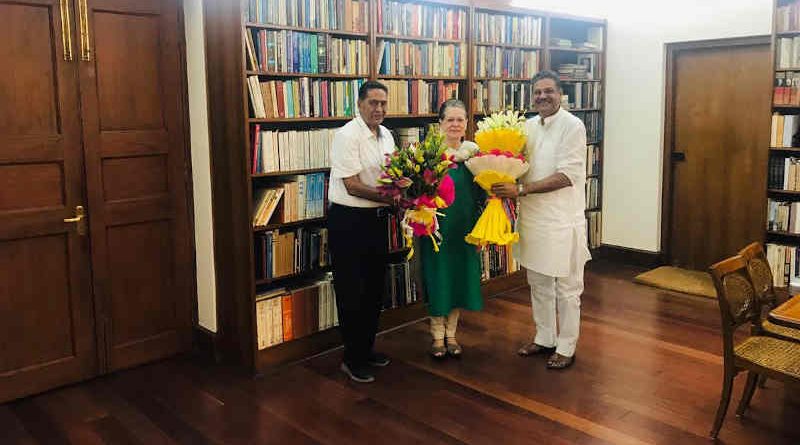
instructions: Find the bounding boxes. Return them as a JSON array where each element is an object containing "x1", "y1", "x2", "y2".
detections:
[{"x1": 75, "y1": 0, "x2": 194, "y2": 371}]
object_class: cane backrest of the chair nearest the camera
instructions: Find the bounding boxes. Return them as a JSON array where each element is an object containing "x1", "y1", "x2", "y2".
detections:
[{"x1": 709, "y1": 255, "x2": 761, "y2": 350}]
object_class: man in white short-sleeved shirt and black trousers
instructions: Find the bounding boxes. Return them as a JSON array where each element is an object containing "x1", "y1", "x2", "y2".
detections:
[{"x1": 328, "y1": 81, "x2": 394, "y2": 383}]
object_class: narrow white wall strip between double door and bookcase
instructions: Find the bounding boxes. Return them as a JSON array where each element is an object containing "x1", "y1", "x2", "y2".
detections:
[{"x1": 183, "y1": 0, "x2": 217, "y2": 332}]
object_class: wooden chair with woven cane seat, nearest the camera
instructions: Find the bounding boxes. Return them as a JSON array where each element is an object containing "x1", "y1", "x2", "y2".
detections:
[{"x1": 710, "y1": 255, "x2": 800, "y2": 439}]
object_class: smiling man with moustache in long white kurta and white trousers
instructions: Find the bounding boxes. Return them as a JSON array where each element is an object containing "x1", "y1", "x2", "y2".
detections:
[{"x1": 492, "y1": 71, "x2": 591, "y2": 369}]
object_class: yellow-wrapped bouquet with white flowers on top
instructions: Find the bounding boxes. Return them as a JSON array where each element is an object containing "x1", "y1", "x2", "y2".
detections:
[{"x1": 465, "y1": 111, "x2": 530, "y2": 246}]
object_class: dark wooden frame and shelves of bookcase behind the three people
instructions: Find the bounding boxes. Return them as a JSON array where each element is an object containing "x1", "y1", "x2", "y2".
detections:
[{"x1": 205, "y1": 0, "x2": 605, "y2": 373}]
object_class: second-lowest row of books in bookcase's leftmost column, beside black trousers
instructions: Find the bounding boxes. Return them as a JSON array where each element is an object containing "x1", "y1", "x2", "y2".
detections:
[{"x1": 253, "y1": 227, "x2": 330, "y2": 280}]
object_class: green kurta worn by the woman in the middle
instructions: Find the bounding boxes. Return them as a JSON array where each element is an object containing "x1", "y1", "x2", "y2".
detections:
[{"x1": 421, "y1": 162, "x2": 483, "y2": 317}]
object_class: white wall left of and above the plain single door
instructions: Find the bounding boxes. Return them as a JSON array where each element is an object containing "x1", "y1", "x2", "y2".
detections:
[{"x1": 514, "y1": 0, "x2": 772, "y2": 252}]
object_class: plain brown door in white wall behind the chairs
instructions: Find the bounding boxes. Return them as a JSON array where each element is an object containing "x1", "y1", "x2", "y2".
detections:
[{"x1": 665, "y1": 37, "x2": 771, "y2": 270}]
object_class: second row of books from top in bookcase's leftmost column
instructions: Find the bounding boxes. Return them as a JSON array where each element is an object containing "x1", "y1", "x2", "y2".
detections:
[{"x1": 245, "y1": 29, "x2": 369, "y2": 77}]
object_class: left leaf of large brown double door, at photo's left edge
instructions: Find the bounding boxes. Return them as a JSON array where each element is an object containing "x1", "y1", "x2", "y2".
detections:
[{"x1": 0, "y1": 0, "x2": 97, "y2": 402}]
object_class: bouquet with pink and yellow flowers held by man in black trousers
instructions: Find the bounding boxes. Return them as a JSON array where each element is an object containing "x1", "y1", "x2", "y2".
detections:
[{"x1": 378, "y1": 129, "x2": 455, "y2": 258}]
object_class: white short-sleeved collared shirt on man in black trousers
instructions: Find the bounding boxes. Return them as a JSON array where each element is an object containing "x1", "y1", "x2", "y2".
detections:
[{"x1": 328, "y1": 117, "x2": 394, "y2": 207}]
